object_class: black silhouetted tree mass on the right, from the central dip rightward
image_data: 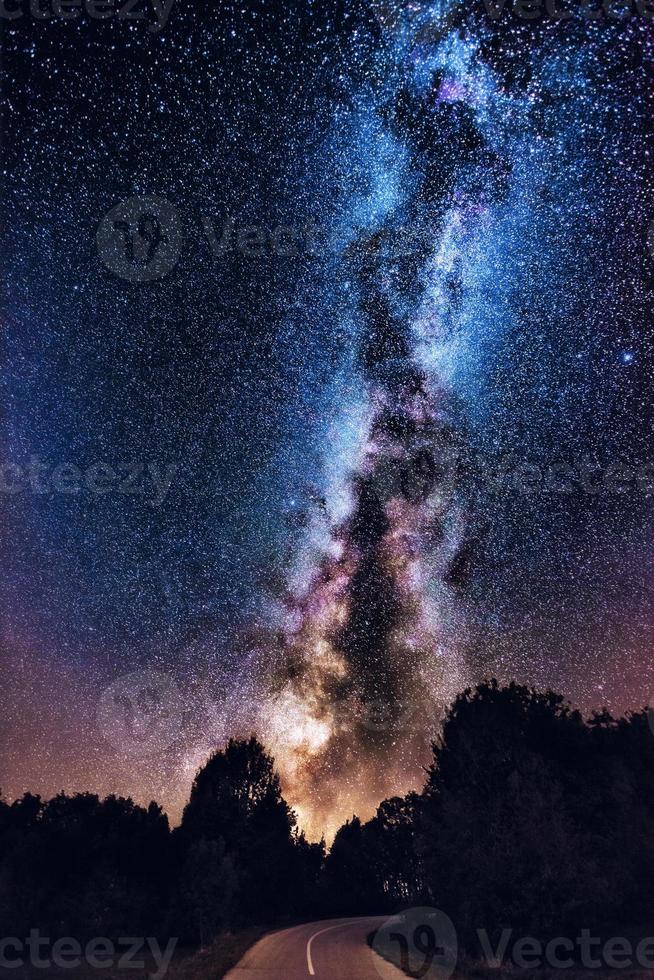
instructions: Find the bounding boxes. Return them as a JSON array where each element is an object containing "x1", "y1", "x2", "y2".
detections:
[{"x1": 325, "y1": 681, "x2": 654, "y2": 948}]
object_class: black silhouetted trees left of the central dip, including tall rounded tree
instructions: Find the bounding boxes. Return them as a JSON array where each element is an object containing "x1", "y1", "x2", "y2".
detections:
[{"x1": 0, "y1": 738, "x2": 325, "y2": 946}]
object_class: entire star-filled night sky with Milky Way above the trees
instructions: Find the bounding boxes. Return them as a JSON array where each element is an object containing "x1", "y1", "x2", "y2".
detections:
[{"x1": 0, "y1": 0, "x2": 654, "y2": 836}]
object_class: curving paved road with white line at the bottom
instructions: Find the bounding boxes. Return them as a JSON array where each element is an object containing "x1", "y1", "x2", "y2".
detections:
[{"x1": 225, "y1": 916, "x2": 406, "y2": 980}]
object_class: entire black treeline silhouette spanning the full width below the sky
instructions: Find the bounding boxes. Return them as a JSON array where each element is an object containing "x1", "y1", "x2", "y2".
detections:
[{"x1": 0, "y1": 681, "x2": 654, "y2": 945}]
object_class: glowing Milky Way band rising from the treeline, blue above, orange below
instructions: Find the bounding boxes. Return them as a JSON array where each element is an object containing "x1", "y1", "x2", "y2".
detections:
[{"x1": 246, "y1": 5, "x2": 654, "y2": 830}]
